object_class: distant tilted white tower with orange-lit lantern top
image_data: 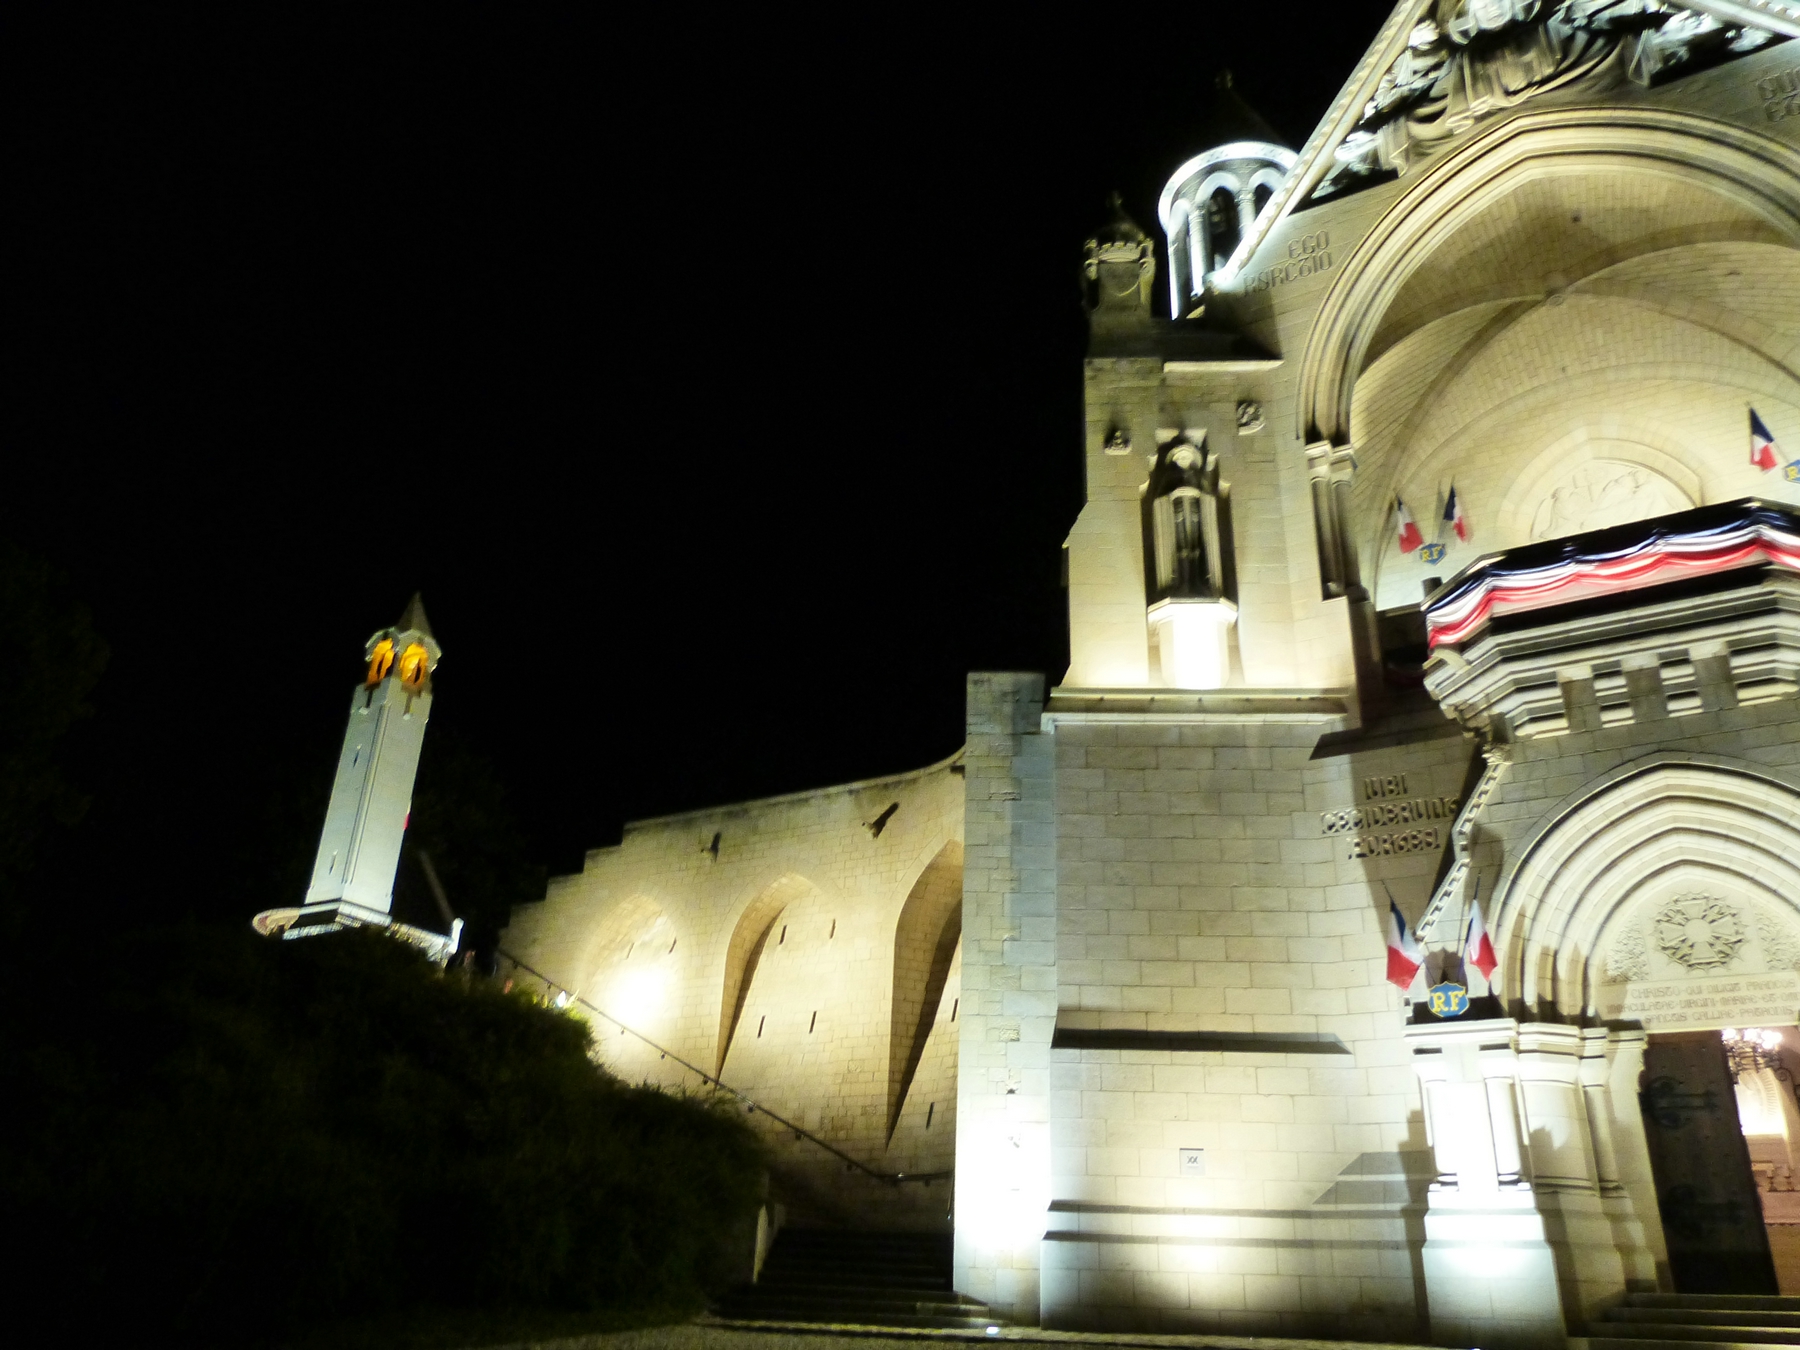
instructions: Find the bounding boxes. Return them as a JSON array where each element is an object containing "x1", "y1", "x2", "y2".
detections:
[{"x1": 257, "y1": 596, "x2": 457, "y2": 956}]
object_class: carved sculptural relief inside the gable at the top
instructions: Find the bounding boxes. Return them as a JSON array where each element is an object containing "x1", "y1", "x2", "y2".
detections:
[{"x1": 1312, "y1": 0, "x2": 1778, "y2": 198}]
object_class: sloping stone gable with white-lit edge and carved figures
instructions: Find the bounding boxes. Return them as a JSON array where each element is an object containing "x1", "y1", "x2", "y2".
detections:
[{"x1": 1217, "y1": 0, "x2": 1800, "y2": 290}]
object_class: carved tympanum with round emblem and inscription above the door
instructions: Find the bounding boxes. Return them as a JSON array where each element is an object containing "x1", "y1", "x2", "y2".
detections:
[{"x1": 1595, "y1": 889, "x2": 1800, "y2": 1031}]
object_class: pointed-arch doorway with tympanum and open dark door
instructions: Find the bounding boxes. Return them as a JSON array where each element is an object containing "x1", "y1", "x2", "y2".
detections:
[{"x1": 1496, "y1": 752, "x2": 1800, "y2": 1294}]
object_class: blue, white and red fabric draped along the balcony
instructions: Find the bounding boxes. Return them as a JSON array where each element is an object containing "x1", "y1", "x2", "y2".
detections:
[{"x1": 1424, "y1": 499, "x2": 1800, "y2": 646}]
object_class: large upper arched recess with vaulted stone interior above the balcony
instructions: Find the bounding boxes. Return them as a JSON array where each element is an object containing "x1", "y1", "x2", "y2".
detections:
[{"x1": 1298, "y1": 108, "x2": 1800, "y2": 630}]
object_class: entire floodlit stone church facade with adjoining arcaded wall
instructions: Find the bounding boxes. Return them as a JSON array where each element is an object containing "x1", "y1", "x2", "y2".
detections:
[{"x1": 506, "y1": 0, "x2": 1800, "y2": 1346}]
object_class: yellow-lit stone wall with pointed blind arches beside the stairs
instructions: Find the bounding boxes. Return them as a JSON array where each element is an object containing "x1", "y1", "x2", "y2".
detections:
[{"x1": 502, "y1": 760, "x2": 963, "y2": 1228}]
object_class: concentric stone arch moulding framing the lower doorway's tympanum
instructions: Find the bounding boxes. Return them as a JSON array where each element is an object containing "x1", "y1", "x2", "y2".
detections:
[{"x1": 1494, "y1": 754, "x2": 1800, "y2": 1019}]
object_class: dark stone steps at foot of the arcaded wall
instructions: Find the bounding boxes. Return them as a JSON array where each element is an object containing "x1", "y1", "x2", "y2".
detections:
[{"x1": 715, "y1": 1228, "x2": 999, "y2": 1330}]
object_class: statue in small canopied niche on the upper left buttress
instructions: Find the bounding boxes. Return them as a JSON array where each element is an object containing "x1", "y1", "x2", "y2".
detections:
[{"x1": 1143, "y1": 432, "x2": 1235, "y2": 605}]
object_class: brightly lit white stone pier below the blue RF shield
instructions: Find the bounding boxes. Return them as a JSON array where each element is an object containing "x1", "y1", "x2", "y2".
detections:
[{"x1": 1406, "y1": 1019, "x2": 1568, "y2": 1350}]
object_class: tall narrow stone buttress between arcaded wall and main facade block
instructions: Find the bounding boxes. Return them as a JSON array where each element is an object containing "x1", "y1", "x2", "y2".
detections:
[{"x1": 956, "y1": 673, "x2": 1057, "y2": 1325}]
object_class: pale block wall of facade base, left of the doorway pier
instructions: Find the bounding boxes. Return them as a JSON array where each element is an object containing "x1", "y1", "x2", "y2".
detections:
[{"x1": 1042, "y1": 709, "x2": 1471, "y2": 1339}]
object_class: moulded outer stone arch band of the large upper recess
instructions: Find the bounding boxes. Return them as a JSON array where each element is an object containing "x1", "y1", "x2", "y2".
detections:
[{"x1": 1296, "y1": 108, "x2": 1800, "y2": 443}]
